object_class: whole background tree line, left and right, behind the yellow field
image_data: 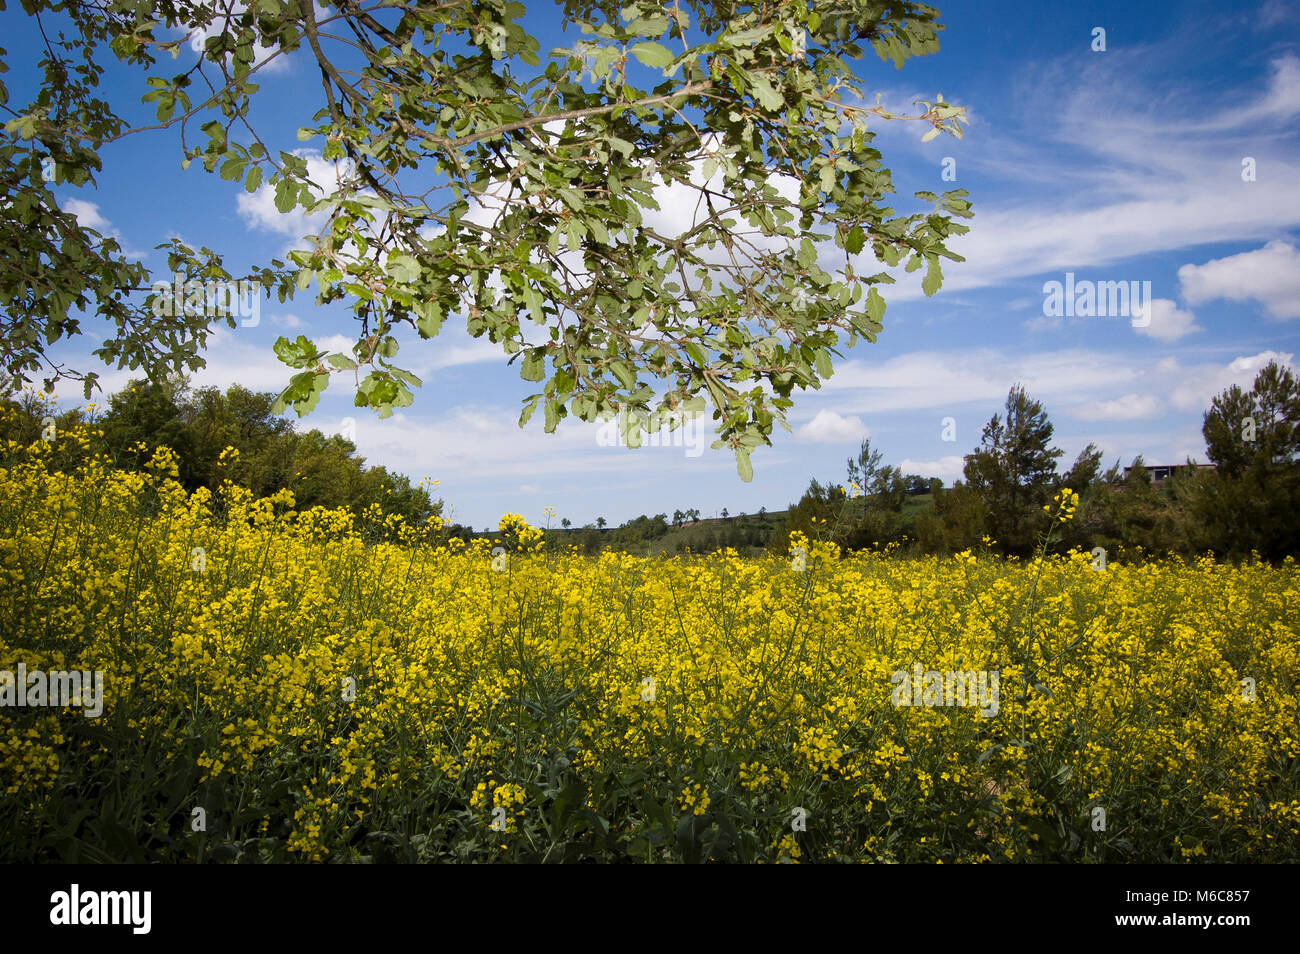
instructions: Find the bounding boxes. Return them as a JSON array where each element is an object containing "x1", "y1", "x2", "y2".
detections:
[{"x1": 0, "y1": 361, "x2": 1300, "y2": 560}]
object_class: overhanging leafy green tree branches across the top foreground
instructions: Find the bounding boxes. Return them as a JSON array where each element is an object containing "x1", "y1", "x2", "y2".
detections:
[{"x1": 0, "y1": 0, "x2": 971, "y2": 480}]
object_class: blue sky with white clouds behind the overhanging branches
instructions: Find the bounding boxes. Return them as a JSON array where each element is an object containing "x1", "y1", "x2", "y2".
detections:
[{"x1": 0, "y1": 0, "x2": 1300, "y2": 528}]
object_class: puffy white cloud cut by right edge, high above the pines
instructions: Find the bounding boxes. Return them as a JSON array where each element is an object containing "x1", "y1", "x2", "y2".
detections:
[{"x1": 1178, "y1": 239, "x2": 1300, "y2": 318}]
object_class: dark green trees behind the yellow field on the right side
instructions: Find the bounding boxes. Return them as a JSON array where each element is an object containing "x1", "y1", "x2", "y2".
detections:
[{"x1": 770, "y1": 361, "x2": 1300, "y2": 560}]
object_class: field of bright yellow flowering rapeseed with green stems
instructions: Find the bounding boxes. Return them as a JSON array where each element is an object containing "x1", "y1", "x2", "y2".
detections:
[{"x1": 0, "y1": 445, "x2": 1300, "y2": 863}]
